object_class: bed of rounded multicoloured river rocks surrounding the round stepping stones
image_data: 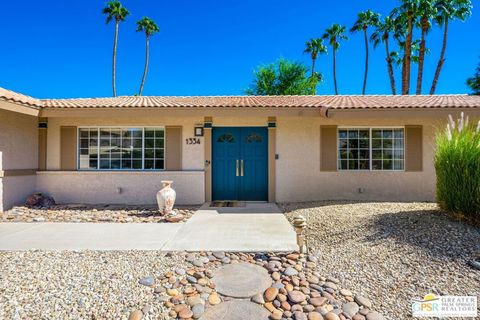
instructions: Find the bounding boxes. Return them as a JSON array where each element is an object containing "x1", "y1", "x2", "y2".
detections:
[{"x1": 131, "y1": 252, "x2": 384, "y2": 320}]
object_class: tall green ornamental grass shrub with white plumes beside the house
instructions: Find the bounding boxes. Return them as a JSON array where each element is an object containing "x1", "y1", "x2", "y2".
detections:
[{"x1": 435, "y1": 112, "x2": 480, "y2": 221}]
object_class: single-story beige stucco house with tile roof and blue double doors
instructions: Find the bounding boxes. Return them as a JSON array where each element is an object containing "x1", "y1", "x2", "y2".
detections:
[{"x1": 0, "y1": 88, "x2": 480, "y2": 211}]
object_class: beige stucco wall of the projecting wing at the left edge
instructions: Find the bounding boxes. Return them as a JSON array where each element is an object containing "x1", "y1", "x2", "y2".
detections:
[{"x1": 0, "y1": 109, "x2": 38, "y2": 211}]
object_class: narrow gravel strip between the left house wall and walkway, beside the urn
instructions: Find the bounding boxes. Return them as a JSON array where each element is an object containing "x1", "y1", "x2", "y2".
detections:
[{"x1": 0, "y1": 204, "x2": 198, "y2": 223}]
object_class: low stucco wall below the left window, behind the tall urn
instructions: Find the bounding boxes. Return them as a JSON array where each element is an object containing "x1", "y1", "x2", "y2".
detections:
[{"x1": 36, "y1": 171, "x2": 205, "y2": 205}]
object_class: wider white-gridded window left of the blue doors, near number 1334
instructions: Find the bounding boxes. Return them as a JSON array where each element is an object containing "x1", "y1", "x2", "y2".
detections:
[{"x1": 78, "y1": 128, "x2": 165, "y2": 170}]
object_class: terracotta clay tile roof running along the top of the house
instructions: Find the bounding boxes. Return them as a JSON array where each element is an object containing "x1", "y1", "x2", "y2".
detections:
[{"x1": 0, "y1": 88, "x2": 480, "y2": 110}]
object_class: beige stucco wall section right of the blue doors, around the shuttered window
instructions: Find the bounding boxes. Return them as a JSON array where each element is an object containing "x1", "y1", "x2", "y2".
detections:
[{"x1": 276, "y1": 114, "x2": 452, "y2": 202}]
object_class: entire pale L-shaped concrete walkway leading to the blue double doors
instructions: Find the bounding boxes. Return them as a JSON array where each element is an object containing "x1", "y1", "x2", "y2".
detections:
[{"x1": 0, "y1": 203, "x2": 297, "y2": 251}]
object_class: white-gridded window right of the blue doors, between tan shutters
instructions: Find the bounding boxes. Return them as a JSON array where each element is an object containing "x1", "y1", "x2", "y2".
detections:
[{"x1": 338, "y1": 128, "x2": 405, "y2": 170}]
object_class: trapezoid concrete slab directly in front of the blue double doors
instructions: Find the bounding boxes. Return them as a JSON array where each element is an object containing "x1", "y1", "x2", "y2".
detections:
[{"x1": 164, "y1": 203, "x2": 298, "y2": 252}]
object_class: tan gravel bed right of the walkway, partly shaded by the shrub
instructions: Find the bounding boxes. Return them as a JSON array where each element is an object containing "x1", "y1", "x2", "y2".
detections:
[{"x1": 281, "y1": 201, "x2": 480, "y2": 319}]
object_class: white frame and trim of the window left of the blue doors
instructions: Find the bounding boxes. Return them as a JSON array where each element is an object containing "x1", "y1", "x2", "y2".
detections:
[{"x1": 75, "y1": 125, "x2": 167, "y2": 172}]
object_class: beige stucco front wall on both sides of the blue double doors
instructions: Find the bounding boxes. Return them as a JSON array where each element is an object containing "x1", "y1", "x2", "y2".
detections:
[{"x1": 37, "y1": 110, "x2": 480, "y2": 204}]
